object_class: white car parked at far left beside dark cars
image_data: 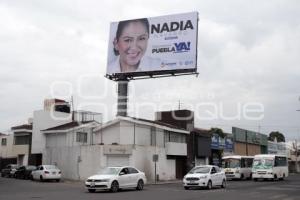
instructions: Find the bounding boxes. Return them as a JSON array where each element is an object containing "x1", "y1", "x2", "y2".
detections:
[{"x1": 30, "y1": 165, "x2": 61, "y2": 182}]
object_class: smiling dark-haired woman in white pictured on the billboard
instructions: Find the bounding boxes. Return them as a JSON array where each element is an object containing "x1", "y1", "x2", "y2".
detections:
[{"x1": 108, "y1": 18, "x2": 160, "y2": 73}]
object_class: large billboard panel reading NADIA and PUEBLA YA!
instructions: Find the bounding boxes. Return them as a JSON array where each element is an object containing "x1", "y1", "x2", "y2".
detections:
[{"x1": 106, "y1": 12, "x2": 198, "y2": 77}]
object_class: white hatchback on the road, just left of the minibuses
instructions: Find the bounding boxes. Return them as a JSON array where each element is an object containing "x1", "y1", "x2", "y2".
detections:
[{"x1": 183, "y1": 165, "x2": 226, "y2": 190}]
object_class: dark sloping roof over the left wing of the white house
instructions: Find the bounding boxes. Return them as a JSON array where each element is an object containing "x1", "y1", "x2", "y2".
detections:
[{"x1": 41, "y1": 121, "x2": 99, "y2": 133}]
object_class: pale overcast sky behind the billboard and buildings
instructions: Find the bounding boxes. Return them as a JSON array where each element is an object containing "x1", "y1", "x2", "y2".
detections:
[{"x1": 0, "y1": 0, "x2": 300, "y2": 139}]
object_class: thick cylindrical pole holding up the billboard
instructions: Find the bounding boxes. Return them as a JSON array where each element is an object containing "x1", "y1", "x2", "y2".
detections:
[{"x1": 117, "y1": 77, "x2": 129, "y2": 117}]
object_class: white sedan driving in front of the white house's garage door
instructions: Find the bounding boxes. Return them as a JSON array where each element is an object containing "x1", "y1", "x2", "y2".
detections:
[{"x1": 85, "y1": 166, "x2": 146, "y2": 192}]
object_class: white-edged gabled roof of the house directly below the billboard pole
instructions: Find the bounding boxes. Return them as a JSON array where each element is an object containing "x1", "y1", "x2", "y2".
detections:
[{"x1": 95, "y1": 116, "x2": 190, "y2": 134}]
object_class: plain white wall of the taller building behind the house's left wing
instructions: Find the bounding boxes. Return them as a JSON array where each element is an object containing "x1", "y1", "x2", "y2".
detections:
[{"x1": 31, "y1": 110, "x2": 72, "y2": 153}]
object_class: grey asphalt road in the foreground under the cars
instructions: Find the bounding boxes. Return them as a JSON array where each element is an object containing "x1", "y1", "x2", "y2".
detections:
[{"x1": 0, "y1": 175, "x2": 300, "y2": 200}]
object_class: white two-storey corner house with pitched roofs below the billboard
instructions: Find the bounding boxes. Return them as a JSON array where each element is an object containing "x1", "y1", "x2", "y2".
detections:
[{"x1": 42, "y1": 117, "x2": 189, "y2": 181}]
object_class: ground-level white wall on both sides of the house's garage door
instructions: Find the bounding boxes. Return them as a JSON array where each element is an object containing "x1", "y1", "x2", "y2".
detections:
[{"x1": 43, "y1": 145, "x2": 176, "y2": 181}]
